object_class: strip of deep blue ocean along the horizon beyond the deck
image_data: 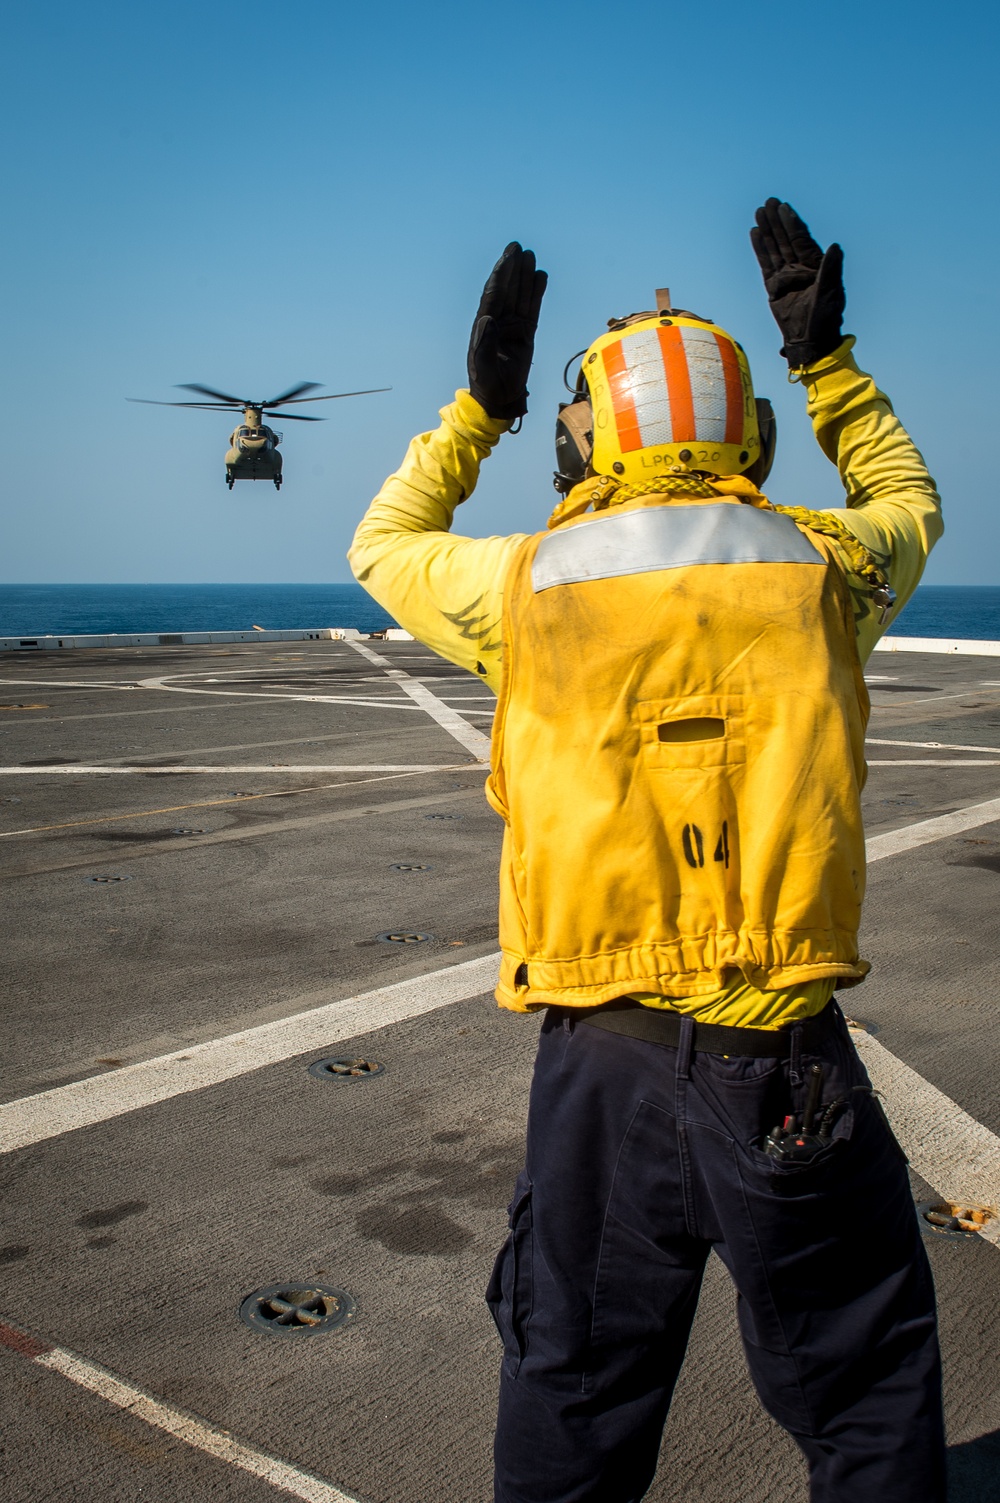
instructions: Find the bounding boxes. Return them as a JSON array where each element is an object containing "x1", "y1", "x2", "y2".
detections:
[{"x1": 0, "y1": 585, "x2": 1000, "y2": 642}]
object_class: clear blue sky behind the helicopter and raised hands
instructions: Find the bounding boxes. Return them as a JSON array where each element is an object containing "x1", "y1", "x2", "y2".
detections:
[{"x1": 0, "y1": 0, "x2": 1000, "y2": 585}]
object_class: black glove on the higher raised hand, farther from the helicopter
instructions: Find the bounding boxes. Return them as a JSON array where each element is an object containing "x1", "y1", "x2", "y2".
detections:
[{"x1": 750, "y1": 198, "x2": 847, "y2": 370}]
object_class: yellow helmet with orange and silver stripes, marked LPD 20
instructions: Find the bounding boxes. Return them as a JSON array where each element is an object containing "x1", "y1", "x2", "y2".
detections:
[{"x1": 556, "y1": 299, "x2": 773, "y2": 488}]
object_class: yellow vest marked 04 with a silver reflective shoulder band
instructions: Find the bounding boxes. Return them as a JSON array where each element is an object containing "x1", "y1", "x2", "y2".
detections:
[{"x1": 487, "y1": 497, "x2": 868, "y2": 1009}]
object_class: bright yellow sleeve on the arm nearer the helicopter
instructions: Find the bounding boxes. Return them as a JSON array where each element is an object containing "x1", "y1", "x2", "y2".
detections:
[{"x1": 347, "y1": 391, "x2": 525, "y2": 691}]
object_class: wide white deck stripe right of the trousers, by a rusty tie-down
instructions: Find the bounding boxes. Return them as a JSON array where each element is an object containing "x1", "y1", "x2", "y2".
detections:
[{"x1": 851, "y1": 1028, "x2": 1000, "y2": 1249}]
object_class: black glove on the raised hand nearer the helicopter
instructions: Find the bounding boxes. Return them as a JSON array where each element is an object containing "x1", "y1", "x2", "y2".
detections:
[{"x1": 469, "y1": 240, "x2": 549, "y2": 419}]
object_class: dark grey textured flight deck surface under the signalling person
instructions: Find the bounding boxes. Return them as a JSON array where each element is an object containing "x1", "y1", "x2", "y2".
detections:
[{"x1": 0, "y1": 643, "x2": 1000, "y2": 1503}]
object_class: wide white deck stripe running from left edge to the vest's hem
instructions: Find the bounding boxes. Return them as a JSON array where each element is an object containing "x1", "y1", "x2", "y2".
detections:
[{"x1": 0, "y1": 953, "x2": 499, "y2": 1153}]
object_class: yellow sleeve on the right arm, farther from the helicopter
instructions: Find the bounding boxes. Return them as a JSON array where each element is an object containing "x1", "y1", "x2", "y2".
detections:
[{"x1": 802, "y1": 337, "x2": 944, "y2": 663}]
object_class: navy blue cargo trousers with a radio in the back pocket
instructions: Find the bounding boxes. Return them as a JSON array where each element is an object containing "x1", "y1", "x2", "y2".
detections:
[{"x1": 487, "y1": 1010, "x2": 944, "y2": 1503}]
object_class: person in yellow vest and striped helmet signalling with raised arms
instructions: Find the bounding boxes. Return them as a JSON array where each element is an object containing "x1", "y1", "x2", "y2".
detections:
[{"x1": 350, "y1": 198, "x2": 944, "y2": 1503}]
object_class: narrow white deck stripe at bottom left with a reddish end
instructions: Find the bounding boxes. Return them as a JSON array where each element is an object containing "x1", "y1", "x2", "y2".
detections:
[{"x1": 33, "y1": 1347, "x2": 356, "y2": 1503}]
